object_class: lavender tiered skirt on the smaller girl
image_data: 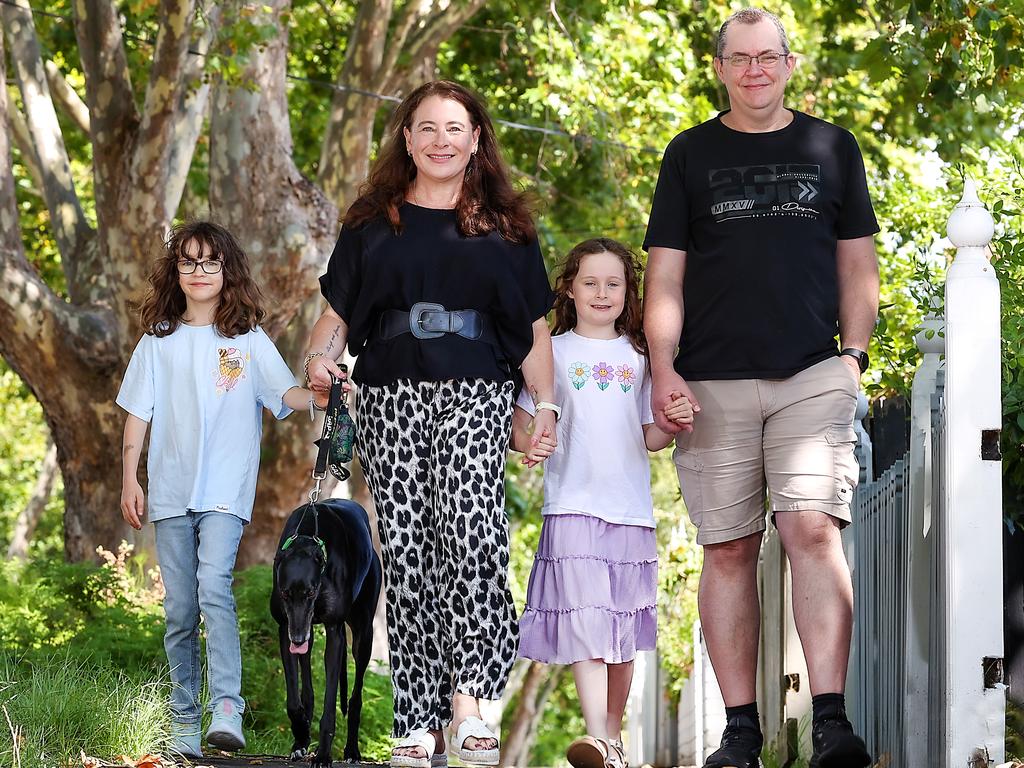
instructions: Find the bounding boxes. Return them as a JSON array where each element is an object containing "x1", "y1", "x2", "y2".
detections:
[{"x1": 519, "y1": 515, "x2": 657, "y2": 664}]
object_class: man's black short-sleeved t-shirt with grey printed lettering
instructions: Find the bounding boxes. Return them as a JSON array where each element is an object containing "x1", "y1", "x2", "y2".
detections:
[{"x1": 643, "y1": 112, "x2": 879, "y2": 380}]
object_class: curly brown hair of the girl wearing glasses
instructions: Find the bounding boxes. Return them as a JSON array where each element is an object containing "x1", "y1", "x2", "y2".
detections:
[{"x1": 139, "y1": 221, "x2": 266, "y2": 338}]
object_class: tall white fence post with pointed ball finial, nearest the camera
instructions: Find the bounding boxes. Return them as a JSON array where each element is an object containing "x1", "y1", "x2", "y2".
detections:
[{"x1": 941, "y1": 179, "x2": 1006, "y2": 768}]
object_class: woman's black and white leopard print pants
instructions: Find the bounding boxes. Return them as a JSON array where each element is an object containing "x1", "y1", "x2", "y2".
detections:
[{"x1": 357, "y1": 379, "x2": 519, "y2": 736}]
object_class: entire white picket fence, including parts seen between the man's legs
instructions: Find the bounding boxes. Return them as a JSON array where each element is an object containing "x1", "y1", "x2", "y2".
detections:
[{"x1": 629, "y1": 180, "x2": 1006, "y2": 768}]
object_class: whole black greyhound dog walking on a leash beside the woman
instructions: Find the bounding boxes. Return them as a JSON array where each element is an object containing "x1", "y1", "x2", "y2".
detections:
[{"x1": 270, "y1": 499, "x2": 382, "y2": 766}]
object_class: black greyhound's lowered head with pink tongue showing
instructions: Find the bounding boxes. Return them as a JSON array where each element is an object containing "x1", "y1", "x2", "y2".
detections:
[{"x1": 273, "y1": 536, "x2": 327, "y2": 653}]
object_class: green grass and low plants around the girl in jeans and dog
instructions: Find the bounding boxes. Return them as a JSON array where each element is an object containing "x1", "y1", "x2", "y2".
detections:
[{"x1": 0, "y1": 558, "x2": 391, "y2": 768}]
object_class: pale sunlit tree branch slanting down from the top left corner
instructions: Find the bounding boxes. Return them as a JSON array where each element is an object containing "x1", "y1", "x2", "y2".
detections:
[{"x1": 0, "y1": 0, "x2": 92, "y2": 288}]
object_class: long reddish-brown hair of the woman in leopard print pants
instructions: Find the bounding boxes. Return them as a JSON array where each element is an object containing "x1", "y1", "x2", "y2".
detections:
[{"x1": 345, "y1": 80, "x2": 537, "y2": 243}]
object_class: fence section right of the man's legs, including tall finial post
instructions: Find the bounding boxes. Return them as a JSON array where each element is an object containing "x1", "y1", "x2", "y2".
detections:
[{"x1": 848, "y1": 181, "x2": 1006, "y2": 768}]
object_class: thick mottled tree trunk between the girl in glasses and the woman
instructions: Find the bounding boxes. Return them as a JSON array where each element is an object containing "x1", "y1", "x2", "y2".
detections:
[{"x1": 210, "y1": 0, "x2": 338, "y2": 567}]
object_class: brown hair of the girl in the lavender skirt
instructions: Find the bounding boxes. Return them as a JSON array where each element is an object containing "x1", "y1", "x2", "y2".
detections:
[{"x1": 552, "y1": 238, "x2": 647, "y2": 355}]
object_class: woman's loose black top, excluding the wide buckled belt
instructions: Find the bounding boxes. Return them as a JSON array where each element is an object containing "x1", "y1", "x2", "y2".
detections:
[{"x1": 321, "y1": 203, "x2": 554, "y2": 386}]
